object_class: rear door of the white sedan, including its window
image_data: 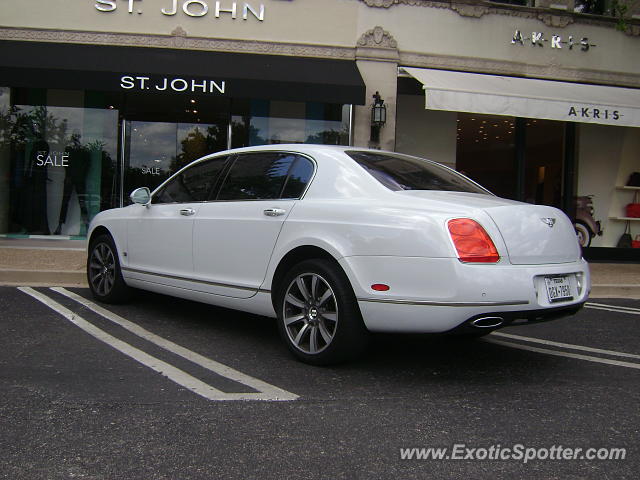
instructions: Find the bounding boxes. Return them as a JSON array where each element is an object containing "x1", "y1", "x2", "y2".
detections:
[{"x1": 193, "y1": 151, "x2": 314, "y2": 298}]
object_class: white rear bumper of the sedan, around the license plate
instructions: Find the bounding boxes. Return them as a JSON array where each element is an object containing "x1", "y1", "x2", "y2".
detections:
[{"x1": 341, "y1": 257, "x2": 590, "y2": 333}]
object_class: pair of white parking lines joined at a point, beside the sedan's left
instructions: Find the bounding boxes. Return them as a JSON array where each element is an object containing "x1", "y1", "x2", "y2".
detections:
[{"x1": 18, "y1": 287, "x2": 298, "y2": 401}]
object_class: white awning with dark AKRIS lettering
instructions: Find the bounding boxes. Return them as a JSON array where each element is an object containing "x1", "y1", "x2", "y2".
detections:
[{"x1": 403, "y1": 67, "x2": 640, "y2": 127}]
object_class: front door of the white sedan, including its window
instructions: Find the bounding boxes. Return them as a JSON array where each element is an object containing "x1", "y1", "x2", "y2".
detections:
[{"x1": 125, "y1": 156, "x2": 228, "y2": 286}]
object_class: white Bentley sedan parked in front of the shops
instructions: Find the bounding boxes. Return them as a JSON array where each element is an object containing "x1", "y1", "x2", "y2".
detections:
[{"x1": 87, "y1": 145, "x2": 590, "y2": 364}]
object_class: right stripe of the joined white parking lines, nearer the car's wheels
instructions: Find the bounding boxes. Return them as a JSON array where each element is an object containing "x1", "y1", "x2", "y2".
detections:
[{"x1": 51, "y1": 287, "x2": 298, "y2": 400}]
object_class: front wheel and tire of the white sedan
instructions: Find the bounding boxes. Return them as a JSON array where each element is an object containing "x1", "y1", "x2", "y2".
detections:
[{"x1": 87, "y1": 234, "x2": 131, "y2": 303}]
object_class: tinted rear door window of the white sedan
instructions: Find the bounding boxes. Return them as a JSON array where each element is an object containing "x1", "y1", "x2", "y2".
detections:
[{"x1": 218, "y1": 152, "x2": 297, "y2": 200}]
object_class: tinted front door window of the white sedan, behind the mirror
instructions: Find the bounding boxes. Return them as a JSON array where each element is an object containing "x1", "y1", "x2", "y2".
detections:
[{"x1": 152, "y1": 157, "x2": 228, "y2": 203}]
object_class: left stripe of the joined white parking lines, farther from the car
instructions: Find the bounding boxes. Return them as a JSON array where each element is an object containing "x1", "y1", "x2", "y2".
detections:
[{"x1": 19, "y1": 287, "x2": 296, "y2": 400}]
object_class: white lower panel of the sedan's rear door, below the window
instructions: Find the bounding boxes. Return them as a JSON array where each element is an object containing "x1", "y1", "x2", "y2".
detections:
[{"x1": 193, "y1": 200, "x2": 295, "y2": 298}]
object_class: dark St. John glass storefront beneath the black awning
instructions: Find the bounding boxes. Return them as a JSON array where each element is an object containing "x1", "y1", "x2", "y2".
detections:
[{"x1": 0, "y1": 87, "x2": 350, "y2": 238}]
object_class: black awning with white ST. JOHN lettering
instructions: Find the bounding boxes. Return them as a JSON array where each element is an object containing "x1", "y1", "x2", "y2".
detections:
[{"x1": 0, "y1": 41, "x2": 365, "y2": 105}]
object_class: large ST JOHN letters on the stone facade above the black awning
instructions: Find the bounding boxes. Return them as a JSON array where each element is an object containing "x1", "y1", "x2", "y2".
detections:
[{"x1": 95, "y1": 0, "x2": 264, "y2": 22}]
